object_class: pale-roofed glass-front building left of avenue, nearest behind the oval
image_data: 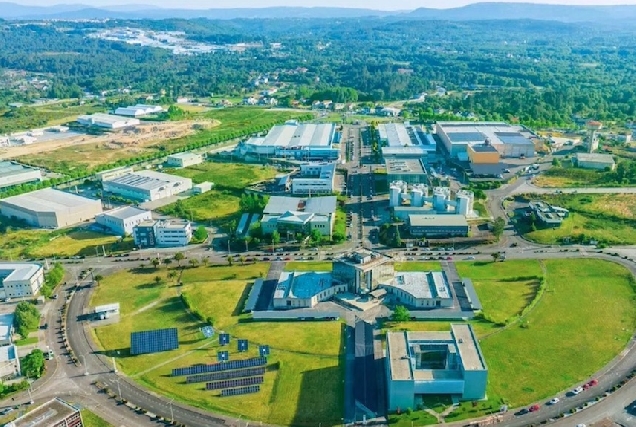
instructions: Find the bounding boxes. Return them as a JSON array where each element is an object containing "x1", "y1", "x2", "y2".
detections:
[{"x1": 261, "y1": 196, "x2": 337, "y2": 236}]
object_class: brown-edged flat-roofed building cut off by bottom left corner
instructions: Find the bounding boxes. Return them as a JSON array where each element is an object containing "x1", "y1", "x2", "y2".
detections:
[{"x1": 6, "y1": 398, "x2": 84, "y2": 427}]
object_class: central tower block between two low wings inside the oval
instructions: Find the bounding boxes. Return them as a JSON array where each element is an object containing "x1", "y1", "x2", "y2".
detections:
[{"x1": 332, "y1": 249, "x2": 394, "y2": 294}]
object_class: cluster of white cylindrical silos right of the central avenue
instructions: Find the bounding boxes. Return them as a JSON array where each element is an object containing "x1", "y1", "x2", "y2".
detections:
[{"x1": 389, "y1": 181, "x2": 476, "y2": 220}]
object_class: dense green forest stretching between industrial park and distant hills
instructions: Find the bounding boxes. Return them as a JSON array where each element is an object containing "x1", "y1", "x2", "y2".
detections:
[{"x1": 0, "y1": 18, "x2": 636, "y2": 127}]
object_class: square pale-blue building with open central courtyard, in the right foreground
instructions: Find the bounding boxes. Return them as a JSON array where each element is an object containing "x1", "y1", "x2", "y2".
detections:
[{"x1": 386, "y1": 324, "x2": 488, "y2": 411}]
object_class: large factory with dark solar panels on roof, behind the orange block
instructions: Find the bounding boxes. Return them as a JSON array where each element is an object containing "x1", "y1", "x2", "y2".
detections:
[{"x1": 435, "y1": 122, "x2": 535, "y2": 161}]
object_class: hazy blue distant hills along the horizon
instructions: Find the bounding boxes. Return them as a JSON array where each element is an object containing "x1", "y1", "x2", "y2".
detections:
[{"x1": 0, "y1": 2, "x2": 636, "y2": 23}]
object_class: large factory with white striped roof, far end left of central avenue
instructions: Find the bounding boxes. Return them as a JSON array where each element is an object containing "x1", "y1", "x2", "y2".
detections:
[{"x1": 237, "y1": 122, "x2": 341, "y2": 162}]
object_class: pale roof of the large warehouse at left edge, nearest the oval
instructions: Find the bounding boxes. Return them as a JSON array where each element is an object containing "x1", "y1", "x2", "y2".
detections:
[{"x1": 0, "y1": 188, "x2": 101, "y2": 212}]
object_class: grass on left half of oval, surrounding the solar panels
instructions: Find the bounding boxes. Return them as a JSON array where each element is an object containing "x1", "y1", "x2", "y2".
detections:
[{"x1": 91, "y1": 263, "x2": 344, "y2": 426}]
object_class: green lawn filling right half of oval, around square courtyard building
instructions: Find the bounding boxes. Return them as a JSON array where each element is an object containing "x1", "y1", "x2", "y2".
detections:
[{"x1": 383, "y1": 259, "x2": 636, "y2": 422}]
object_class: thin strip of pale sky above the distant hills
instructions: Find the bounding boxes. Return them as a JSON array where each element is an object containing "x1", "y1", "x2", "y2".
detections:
[{"x1": 14, "y1": 0, "x2": 636, "y2": 10}]
